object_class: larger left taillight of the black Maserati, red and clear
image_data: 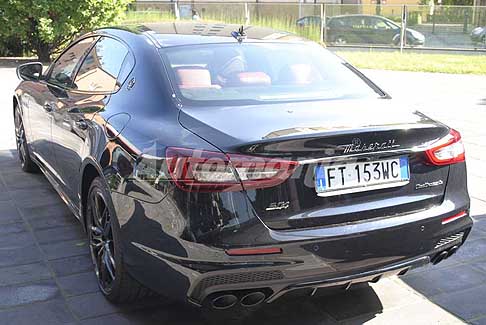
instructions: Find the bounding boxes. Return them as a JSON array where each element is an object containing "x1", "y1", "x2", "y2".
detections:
[{"x1": 166, "y1": 147, "x2": 298, "y2": 192}]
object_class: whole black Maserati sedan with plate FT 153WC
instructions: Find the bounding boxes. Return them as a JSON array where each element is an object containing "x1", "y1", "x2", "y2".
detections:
[{"x1": 12, "y1": 22, "x2": 472, "y2": 311}]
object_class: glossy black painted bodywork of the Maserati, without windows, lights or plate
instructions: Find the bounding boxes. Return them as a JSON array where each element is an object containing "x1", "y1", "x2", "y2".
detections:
[{"x1": 14, "y1": 24, "x2": 472, "y2": 304}]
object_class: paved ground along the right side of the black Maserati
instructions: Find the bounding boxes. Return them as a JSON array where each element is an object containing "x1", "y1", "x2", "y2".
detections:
[{"x1": 368, "y1": 69, "x2": 486, "y2": 324}]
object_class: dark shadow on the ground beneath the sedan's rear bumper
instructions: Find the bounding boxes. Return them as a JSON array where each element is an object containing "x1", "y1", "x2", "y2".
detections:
[{"x1": 106, "y1": 284, "x2": 383, "y2": 325}]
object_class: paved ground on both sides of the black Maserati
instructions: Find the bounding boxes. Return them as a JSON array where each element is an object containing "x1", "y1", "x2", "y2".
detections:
[{"x1": 0, "y1": 62, "x2": 486, "y2": 324}]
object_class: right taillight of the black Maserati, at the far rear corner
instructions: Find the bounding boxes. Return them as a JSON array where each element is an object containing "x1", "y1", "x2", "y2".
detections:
[{"x1": 425, "y1": 129, "x2": 466, "y2": 165}]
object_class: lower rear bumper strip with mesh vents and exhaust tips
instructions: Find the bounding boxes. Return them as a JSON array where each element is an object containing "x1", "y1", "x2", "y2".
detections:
[{"x1": 184, "y1": 220, "x2": 470, "y2": 304}]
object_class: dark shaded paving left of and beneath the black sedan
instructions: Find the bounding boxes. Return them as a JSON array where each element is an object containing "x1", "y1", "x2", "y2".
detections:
[{"x1": 0, "y1": 150, "x2": 383, "y2": 325}]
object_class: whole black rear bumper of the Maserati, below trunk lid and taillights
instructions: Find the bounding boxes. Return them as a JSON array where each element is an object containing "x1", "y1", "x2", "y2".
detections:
[{"x1": 112, "y1": 157, "x2": 472, "y2": 305}]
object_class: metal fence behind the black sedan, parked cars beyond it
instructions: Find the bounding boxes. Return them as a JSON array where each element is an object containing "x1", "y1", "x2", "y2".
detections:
[{"x1": 126, "y1": 1, "x2": 486, "y2": 51}]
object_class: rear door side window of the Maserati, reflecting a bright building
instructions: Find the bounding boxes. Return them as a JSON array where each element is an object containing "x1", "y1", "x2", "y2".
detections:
[{"x1": 74, "y1": 37, "x2": 133, "y2": 92}]
